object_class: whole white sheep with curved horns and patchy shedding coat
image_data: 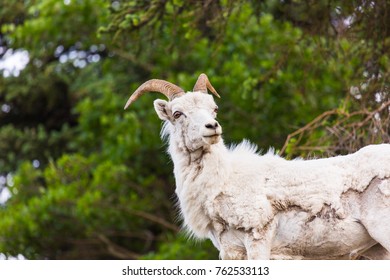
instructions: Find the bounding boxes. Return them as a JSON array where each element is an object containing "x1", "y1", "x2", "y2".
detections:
[{"x1": 125, "y1": 74, "x2": 390, "y2": 259}]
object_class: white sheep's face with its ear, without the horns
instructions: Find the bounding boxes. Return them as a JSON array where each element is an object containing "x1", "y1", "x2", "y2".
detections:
[{"x1": 154, "y1": 92, "x2": 222, "y2": 151}]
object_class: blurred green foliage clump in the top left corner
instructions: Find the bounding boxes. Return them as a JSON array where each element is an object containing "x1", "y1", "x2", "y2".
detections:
[{"x1": 1, "y1": 0, "x2": 108, "y2": 54}]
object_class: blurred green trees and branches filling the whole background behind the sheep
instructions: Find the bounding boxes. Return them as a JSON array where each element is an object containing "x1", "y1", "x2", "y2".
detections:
[{"x1": 0, "y1": 0, "x2": 390, "y2": 259}]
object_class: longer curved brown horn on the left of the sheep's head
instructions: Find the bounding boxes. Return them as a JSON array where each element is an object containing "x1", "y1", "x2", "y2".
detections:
[{"x1": 125, "y1": 79, "x2": 184, "y2": 109}]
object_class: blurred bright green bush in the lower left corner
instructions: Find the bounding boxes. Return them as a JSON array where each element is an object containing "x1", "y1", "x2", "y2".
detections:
[{"x1": 0, "y1": 154, "x2": 174, "y2": 258}]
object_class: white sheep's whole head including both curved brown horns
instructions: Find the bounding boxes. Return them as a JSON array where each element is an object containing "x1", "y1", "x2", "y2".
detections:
[{"x1": 125, "y1": 74, "x2": 222, "y2": 150}]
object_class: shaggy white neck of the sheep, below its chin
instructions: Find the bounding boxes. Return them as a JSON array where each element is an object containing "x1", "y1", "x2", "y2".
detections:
[{"x1": 169, "y1": 137, "x2": 229, "y2": 238}]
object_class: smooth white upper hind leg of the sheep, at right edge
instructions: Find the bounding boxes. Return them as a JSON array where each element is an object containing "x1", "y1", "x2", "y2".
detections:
[{"x1": 361, "y1": 178, "x2": 390, "y2": 253}]
